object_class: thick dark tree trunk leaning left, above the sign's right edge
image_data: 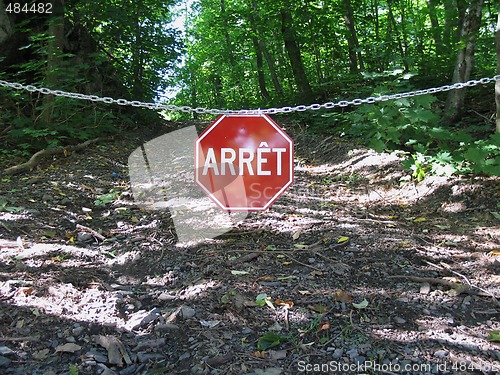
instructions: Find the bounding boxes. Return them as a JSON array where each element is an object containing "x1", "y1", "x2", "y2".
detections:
[{"x1": 281, "y1": 1, "x2": 313, "y2": 102}]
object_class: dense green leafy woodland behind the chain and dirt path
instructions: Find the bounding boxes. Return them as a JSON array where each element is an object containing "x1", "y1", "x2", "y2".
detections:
[{"x1": 0, "y1": 0, "x2": 500, "y2": 179}]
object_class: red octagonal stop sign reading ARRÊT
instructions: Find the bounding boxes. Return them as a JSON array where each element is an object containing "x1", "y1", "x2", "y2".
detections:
[{"x1": 195, "y1": 115, "x2": 293, "y2": 211}]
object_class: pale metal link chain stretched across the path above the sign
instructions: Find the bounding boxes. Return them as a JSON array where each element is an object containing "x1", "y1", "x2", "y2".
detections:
[{"x1": 0, "y1": 75, "x2": 500, "y2": 115}]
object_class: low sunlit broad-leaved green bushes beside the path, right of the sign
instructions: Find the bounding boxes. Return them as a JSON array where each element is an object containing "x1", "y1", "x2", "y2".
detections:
[{"x1": 330, "y1": 81, "x2": 500, "y2": 181}]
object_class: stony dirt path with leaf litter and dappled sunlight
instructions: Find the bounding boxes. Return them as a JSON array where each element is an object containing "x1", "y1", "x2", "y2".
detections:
[{"x1": 0, "y1": 125, "x2": 500, "y2": 375}]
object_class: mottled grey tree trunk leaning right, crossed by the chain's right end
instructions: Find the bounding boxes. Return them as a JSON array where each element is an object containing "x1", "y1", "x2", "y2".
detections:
[{"x1": 443, "y1": 0, "x2": 484, "y2": 124}]
